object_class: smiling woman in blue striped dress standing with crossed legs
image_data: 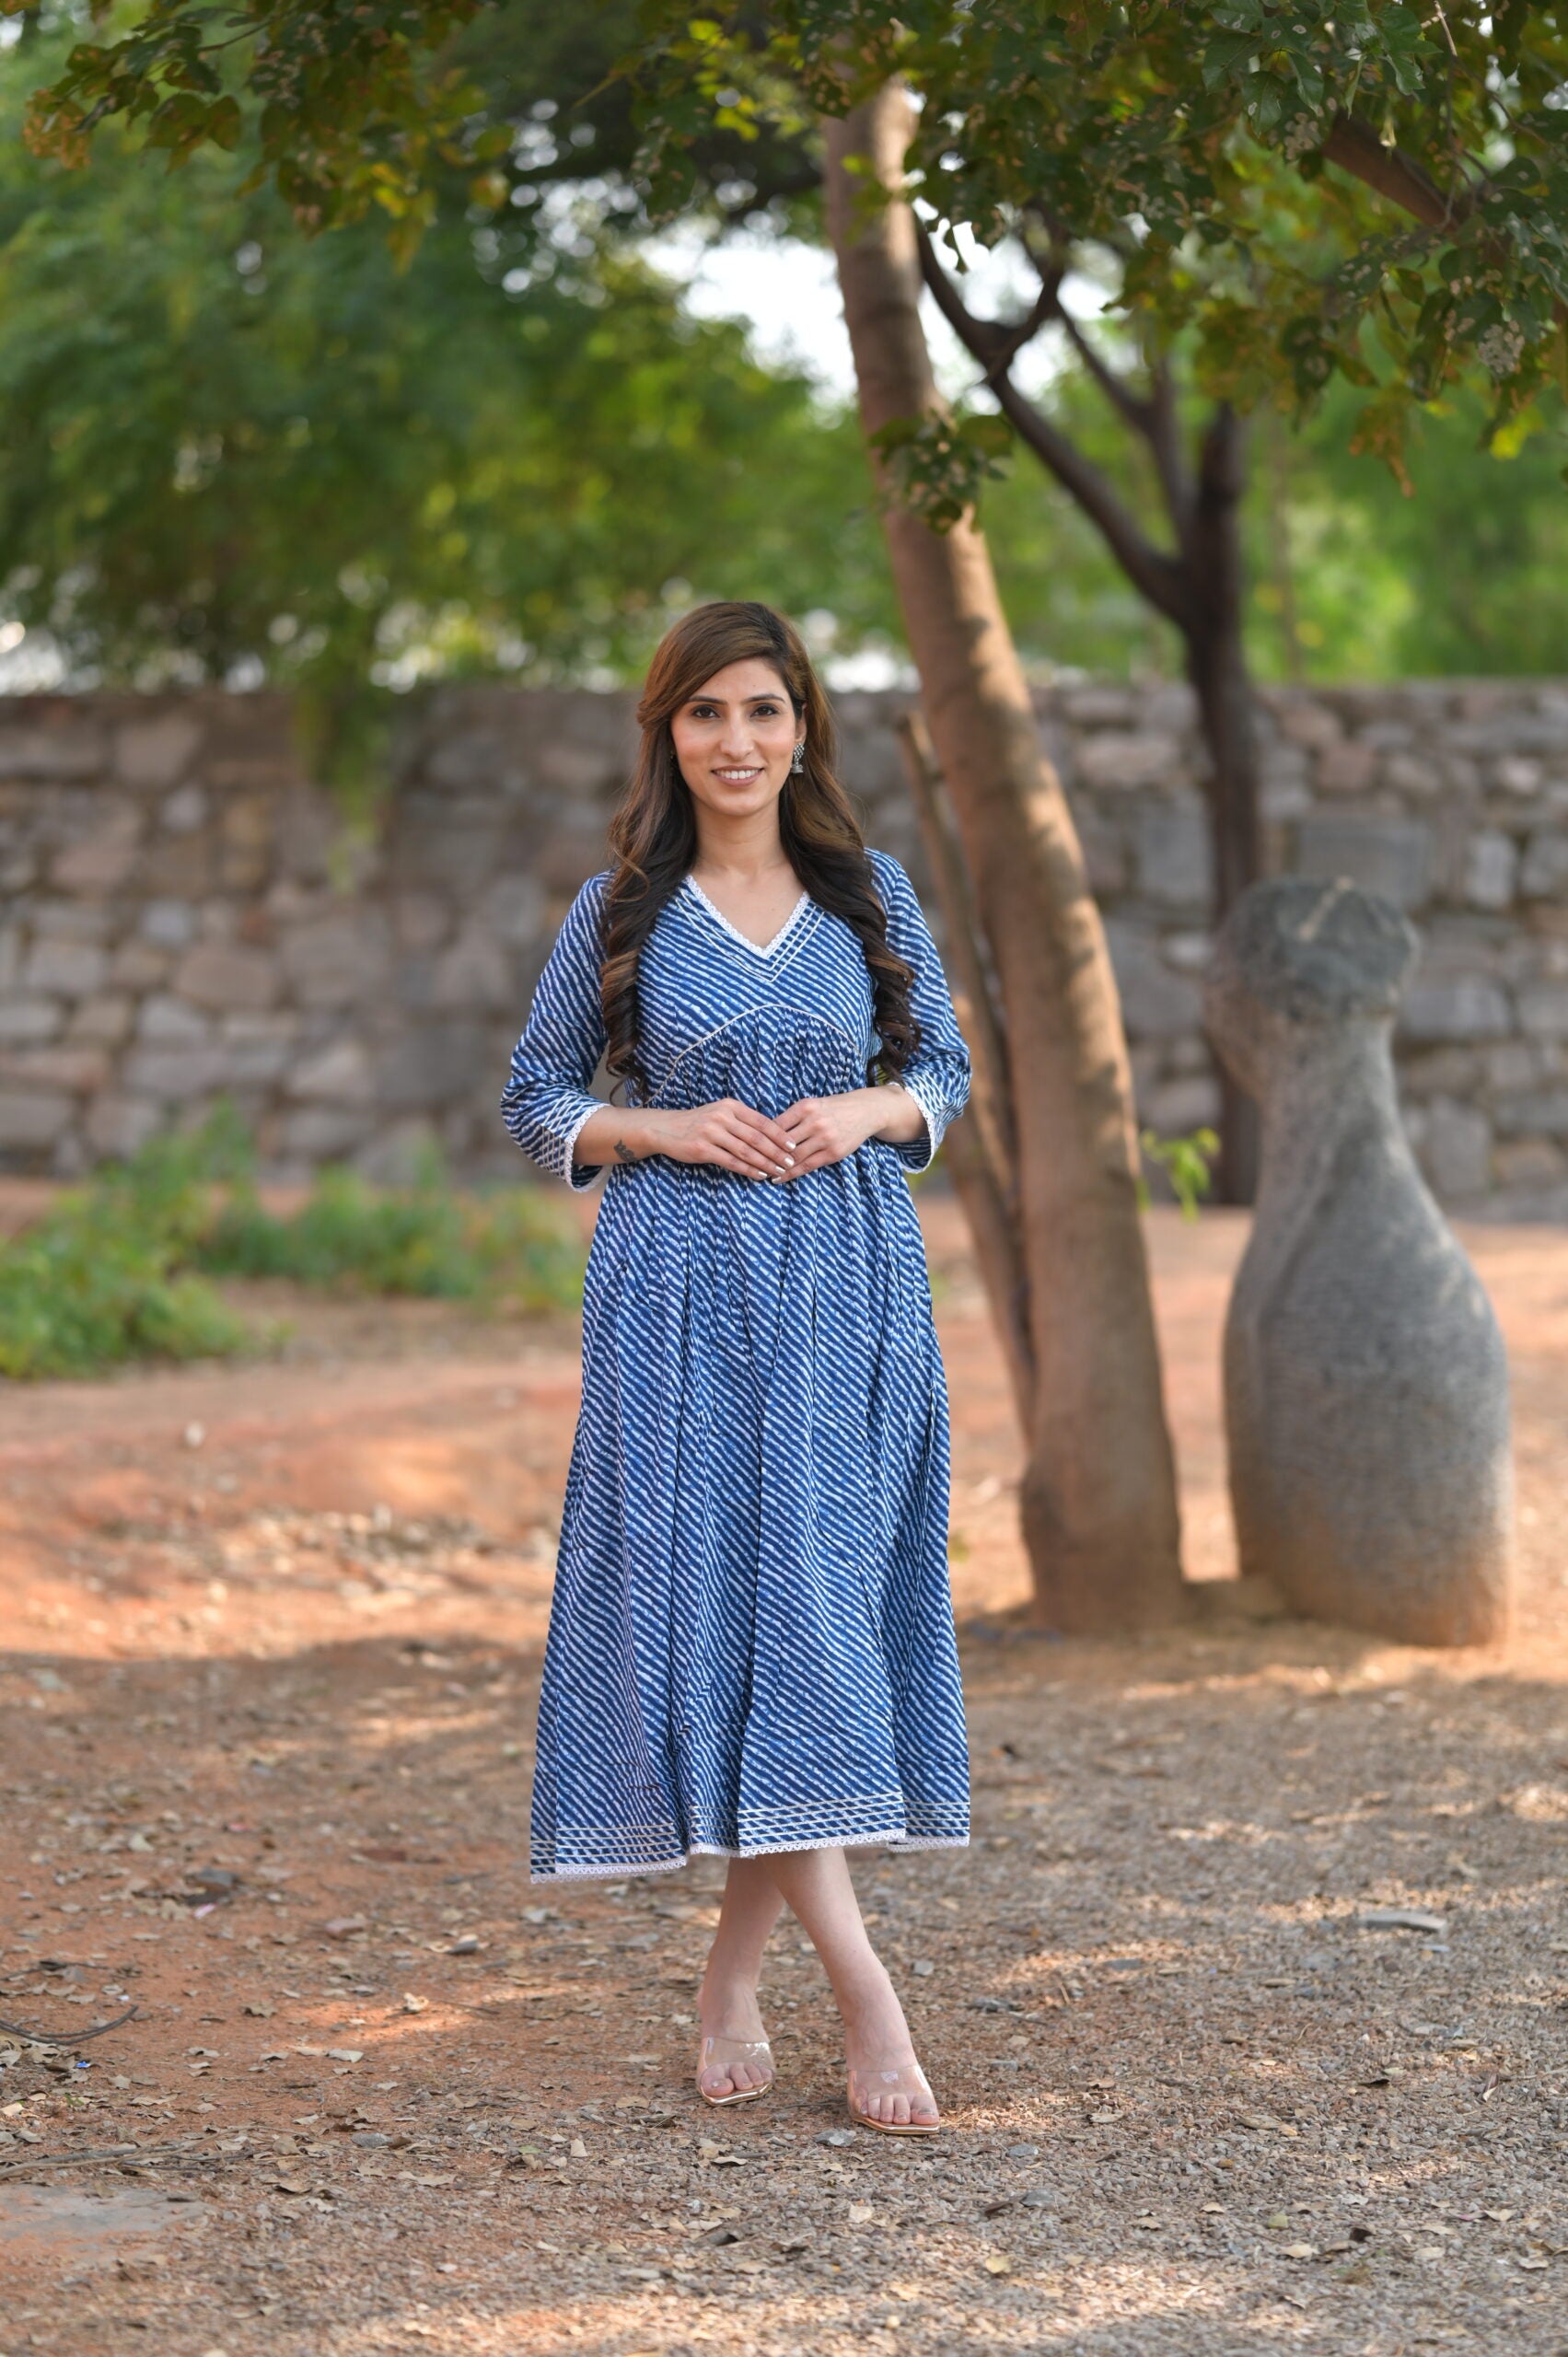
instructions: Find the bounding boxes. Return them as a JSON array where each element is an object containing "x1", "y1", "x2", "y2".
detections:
[{"x1": 502, "y1": 603, "x2": 970, "y2": 2135}]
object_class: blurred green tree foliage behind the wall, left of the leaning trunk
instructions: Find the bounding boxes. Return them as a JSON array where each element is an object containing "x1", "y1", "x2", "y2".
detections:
[{"x1": 0, "y1": 20, "x2": 889, "y2": 697}]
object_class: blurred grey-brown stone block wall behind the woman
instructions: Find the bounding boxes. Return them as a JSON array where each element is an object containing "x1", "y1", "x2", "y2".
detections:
[{"x1": 0, "y1": 681, "x2": 1568, "y2": 1219}]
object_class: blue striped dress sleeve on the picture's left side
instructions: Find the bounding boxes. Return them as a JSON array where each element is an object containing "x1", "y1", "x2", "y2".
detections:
[{"x1": 500, "y1": 870, "x2": 609, "y2": 1190}]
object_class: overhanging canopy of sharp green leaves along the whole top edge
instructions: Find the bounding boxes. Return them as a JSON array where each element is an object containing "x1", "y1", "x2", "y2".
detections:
[{"x1": 24, "y1": 0, "x2": 1568, "y2": 478}]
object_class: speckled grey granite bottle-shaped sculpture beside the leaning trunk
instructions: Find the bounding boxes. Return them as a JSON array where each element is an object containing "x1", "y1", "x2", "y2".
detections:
[{"x1": 1205, "y1": 877, "x2": 1512, "y2": 1645}]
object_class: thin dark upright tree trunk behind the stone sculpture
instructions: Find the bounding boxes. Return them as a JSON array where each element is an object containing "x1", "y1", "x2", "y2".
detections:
[{"x1": 1184, "y1": 403, "x2": 1261, "y2": 1202}]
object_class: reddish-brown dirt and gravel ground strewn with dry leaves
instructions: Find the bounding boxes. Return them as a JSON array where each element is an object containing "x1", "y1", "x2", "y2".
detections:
[{"x1": 0, "y1": 1195, "x2": 1568, "y2": 2357}]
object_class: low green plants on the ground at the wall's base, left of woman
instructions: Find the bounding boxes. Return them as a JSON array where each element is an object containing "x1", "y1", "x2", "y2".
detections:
[{"x1": 0, "y1": 1108, "x2": 585, "y2": 1381}]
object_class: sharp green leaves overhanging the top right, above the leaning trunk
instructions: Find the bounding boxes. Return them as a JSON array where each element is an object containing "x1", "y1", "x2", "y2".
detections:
[{"x1": 627, "y1": 0, "x2": 1568, "y2": 471}]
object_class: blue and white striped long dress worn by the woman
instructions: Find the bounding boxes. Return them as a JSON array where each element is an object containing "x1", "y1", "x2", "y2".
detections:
[{"x1": 502, "y1": 851, "x2": 970, "y2": 1881}]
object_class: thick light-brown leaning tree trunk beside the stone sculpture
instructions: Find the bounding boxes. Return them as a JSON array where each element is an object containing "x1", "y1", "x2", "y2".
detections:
[{"x1": 825, "y1": 83, "x2": 1181, "y2": 1629}]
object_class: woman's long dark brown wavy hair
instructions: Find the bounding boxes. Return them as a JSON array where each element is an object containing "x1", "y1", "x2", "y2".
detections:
[{"x1": 598, "y1": 598, "x2": 920, "y2": 1101}]
